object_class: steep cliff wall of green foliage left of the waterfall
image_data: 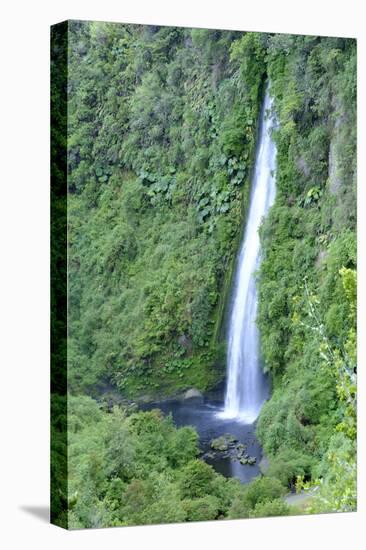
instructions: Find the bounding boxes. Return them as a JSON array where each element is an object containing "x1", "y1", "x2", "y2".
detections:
[{"x1": 68, "y1": 22, "x2": 265, "y2": 397}]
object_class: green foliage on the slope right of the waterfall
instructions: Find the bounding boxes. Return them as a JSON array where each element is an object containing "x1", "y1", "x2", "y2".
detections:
[{"x1": 258, "y1": 35, "x2": 356, "y2": 511}]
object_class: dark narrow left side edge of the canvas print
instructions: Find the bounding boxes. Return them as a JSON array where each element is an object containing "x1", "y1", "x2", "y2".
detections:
[{"x1": 50, "y1": 23, "x2": 67, "y2": 521}]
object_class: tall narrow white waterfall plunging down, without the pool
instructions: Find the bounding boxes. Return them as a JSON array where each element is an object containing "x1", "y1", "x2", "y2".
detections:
[{"x1": 221, "y1": 88, "x2": 276, "y2": 423}]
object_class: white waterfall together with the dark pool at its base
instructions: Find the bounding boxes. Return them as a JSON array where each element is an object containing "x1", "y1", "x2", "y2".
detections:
[{"x1": 141, "y1": 90, "x2": 276, "y2": 483}]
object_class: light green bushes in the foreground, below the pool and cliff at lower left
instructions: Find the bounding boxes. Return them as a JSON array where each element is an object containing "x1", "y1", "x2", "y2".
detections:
[{"x1": 60, "y1": 396, "x2": 287, "y2": 529}]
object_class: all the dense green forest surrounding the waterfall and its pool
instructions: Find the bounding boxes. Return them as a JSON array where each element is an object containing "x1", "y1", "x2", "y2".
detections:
[{"x1": 52, "y1": 21, "x2": 356, "y2": 528}]
